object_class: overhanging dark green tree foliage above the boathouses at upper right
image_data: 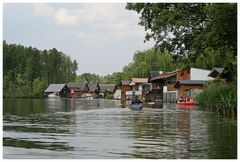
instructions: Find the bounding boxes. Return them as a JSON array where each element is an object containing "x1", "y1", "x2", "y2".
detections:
[{"x1": 126, "y1": 3, "x2": 237, "y2": 77}]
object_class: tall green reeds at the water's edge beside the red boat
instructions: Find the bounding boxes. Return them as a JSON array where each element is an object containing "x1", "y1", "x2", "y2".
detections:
[{"x1": 196, "y1": 80, "x2": 237, "y2": 116}]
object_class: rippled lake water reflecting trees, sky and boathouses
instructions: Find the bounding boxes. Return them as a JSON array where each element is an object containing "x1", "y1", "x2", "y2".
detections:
[{"x1": 3, "y1": 99, "x2": 237, "y2": 159}]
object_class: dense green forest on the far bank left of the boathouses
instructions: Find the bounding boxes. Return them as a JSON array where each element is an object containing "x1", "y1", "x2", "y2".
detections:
[{"x1": 3, "y1": 41, "x2": 78, "y2": 97}]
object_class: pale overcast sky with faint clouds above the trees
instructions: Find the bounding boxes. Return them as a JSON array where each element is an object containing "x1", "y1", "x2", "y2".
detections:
[{"x1": 3, "y1": 3, "x2": 154, "y2": 75}]
